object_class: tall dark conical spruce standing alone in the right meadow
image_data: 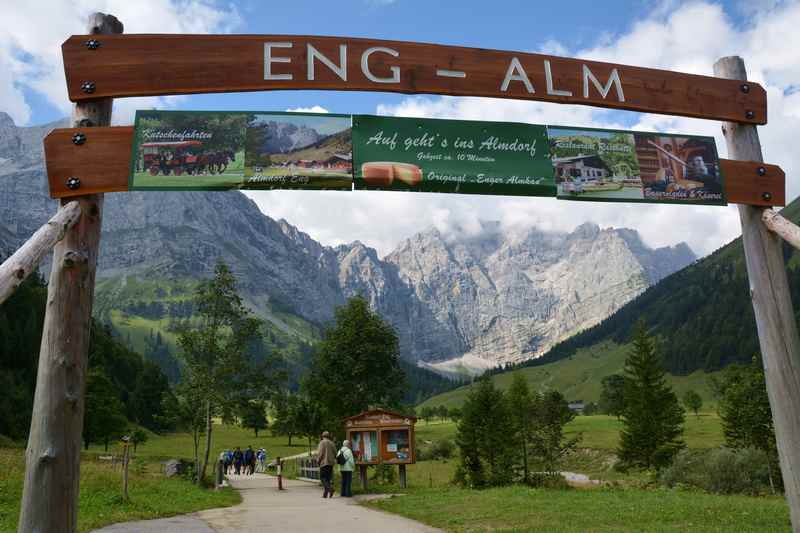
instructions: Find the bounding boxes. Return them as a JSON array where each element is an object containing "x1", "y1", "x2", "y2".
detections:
[{"x1": 617, "y1": 322, "x2": 684, "y2": 468}]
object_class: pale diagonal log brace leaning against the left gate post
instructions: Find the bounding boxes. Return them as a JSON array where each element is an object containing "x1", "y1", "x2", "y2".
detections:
[{"x1": 0, "y1": 202, "x2": 81, "y2": 304}]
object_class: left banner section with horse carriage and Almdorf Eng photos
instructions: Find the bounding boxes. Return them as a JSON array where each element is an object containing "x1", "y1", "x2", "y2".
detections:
[{"x1": 129, "y1": 111, "x2": 353, "y2": 191}]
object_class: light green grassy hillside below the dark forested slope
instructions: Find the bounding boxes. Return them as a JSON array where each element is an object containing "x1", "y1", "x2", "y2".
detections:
[{"x1": 419, "y1": 341, "x2": 713, "y2": 408}]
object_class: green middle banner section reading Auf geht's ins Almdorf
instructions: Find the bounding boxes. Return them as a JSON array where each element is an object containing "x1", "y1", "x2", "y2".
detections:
[{"x1": 353, "y1": 115, "x2": 555, "y2": 196}]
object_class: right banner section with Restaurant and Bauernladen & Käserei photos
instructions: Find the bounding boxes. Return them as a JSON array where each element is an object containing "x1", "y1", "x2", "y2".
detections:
[{"x1": 547, "y1": 126, "x2": 726, "y2": 205}]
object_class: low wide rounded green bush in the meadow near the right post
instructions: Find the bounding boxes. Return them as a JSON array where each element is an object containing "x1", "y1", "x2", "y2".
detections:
[{"x1": 659, "y1": 448, "x2": 770, "y2": 495}]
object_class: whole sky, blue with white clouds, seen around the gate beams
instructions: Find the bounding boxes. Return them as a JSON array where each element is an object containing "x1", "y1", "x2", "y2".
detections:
[{"x1": 0, "y1": 0, "x2": 800, "y2": 255}]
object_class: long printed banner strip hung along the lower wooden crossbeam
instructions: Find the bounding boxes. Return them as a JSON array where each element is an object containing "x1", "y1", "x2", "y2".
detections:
[{"x1": 129, "y1": 111, "x2": 726, "y2": 205}]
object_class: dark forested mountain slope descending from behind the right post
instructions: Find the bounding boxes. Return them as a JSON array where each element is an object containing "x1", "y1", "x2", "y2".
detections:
[{"x1": 510, "y1": 196, "x2": 800, "y2": 375}]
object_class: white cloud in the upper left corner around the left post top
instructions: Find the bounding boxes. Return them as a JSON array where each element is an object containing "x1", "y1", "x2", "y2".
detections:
[{"x1": 0, "y1": 0, "x2": 242, "y2": 124}]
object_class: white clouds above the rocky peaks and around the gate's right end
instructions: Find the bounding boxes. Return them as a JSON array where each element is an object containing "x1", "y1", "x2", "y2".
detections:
[{"x1": 252, "y1": 0, "x2": 800, "y2": 254}]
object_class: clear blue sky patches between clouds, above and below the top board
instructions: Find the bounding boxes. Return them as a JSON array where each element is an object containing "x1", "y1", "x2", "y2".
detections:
[{"x1": 18, "y1": 0, "x2": 760, "y2": 124}]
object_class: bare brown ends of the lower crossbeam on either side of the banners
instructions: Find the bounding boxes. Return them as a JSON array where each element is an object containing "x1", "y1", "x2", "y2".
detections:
[{"x1": 44, "y1": 126, "x2": 786, "y2": 206}]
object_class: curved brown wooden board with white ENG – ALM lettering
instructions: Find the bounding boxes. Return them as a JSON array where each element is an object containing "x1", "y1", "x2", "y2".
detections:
[{"x1": 62, "y1": 35, "x2": 767, "y2": 124}]
